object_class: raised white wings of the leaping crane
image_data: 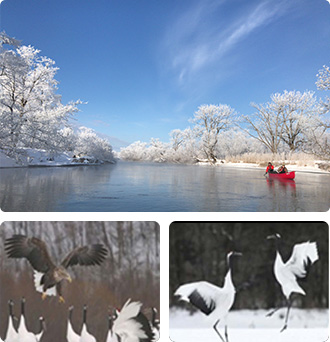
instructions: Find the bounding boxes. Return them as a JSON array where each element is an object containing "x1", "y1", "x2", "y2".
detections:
[{"x1": 286, "y1": 241, "x2": 319, "y2": 278}]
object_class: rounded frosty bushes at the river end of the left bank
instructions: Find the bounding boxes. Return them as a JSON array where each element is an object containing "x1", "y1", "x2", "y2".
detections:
[{"x1": 74, "y1": 127, "x2": 114, "y2": 162}]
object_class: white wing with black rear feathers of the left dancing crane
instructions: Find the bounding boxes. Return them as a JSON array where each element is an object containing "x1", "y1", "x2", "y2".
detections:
[{"x1": 174, "y1": 281, "x2": 221, "y2": 315}]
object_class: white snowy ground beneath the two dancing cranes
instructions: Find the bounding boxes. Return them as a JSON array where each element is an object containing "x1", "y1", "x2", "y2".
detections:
[{"x1": 170, "y1": 308, "x2": 329, "y2": 342}]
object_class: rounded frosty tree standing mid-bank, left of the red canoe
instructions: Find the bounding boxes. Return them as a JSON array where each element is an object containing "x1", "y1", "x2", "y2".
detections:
[{"x1": 191, "y1": 104, "x2": 236, "y2": 162}]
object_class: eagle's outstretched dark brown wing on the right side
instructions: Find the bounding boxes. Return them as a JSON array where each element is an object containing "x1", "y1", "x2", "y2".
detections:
[{"x1": 62, "y1": 244, "x2": 108, "y2": 268}]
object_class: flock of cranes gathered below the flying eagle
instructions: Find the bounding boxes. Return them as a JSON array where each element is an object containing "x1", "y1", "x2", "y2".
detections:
[{"x1": 0, "y1": 298, "x2": 160, "y2": 342}]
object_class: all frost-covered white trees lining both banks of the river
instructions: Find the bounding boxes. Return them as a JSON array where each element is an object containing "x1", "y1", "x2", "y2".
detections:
[{"x1": 0, "y1": 32, "x2": 330, "y2": 167}]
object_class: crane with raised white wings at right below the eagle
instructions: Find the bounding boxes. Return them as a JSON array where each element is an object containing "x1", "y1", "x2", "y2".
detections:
[{"x1": 107, "y1": 299, "x2": 154, "y2": 342}]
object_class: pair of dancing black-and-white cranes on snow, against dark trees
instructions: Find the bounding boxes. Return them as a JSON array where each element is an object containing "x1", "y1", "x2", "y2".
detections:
[{"x1": 174, "y1": 234, "x2": 318, "y2": 342}]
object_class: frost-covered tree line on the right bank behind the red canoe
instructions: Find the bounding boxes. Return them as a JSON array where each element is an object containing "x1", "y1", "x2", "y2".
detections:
[{"x1": 119, "y1": 66, "x2": 330, "y2": 163}]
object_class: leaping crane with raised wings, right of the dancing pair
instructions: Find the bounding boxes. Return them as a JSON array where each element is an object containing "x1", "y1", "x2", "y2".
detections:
[{"x1": 267, "y1": 234, "x2": 319, "y2": 332}]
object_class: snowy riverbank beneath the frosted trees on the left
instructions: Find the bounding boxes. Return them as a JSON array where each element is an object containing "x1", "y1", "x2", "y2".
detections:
[{"x1": 0, "y1": 149, "x2": 111, "y2": 168}]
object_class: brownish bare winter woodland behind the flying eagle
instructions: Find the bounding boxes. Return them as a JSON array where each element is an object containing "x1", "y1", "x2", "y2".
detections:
[{"x1": 0, "y1": 222, "x2": 159, "y2": 342}]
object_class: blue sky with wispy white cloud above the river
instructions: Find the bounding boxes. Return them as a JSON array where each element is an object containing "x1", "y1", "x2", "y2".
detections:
[{"x1": 0, "y1": 0, "x2": 330, "y2": 148}]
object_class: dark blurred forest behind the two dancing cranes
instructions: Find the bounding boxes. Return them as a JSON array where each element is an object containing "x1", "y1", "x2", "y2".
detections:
[{"x1": 169, "y1": 222, "x2": 329, "y2": 312}]
